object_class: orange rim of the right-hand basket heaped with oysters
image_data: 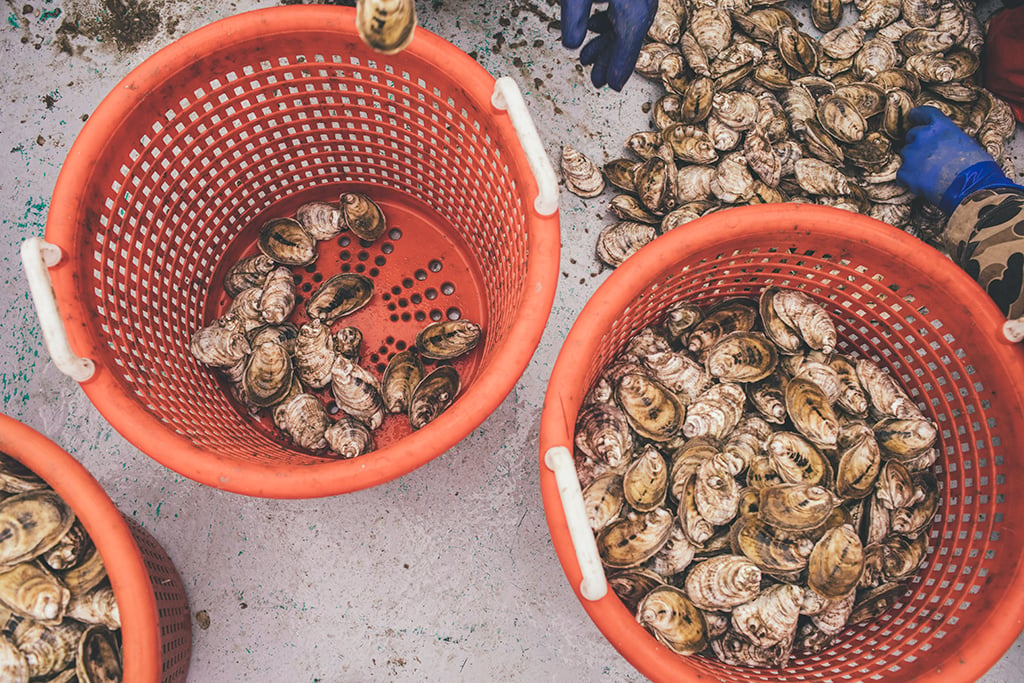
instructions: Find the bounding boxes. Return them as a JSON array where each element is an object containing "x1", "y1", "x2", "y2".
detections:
[{"x1": 540, "y1": 204, "x2": 1024, "y2": 683}]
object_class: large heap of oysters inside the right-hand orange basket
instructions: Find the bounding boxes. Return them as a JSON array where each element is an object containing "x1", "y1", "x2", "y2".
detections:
[{"x1": 574, "y1": 287, "x2": 939, "y2": 667}]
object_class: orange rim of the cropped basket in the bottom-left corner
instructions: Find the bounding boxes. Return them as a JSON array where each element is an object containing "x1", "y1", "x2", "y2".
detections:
[{"x1": 0, "y1": 414, "x2": 167, "y2": 681}]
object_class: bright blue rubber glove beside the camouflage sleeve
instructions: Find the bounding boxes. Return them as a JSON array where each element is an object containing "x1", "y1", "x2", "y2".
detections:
[{"x1": 896, "y1": 106, "x2": 1017, "y2": 214}]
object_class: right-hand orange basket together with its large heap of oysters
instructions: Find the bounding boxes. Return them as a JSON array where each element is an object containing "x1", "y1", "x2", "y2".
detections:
[{"x1": 541, "y1": 205, "x2": 1024, "y2": 681}]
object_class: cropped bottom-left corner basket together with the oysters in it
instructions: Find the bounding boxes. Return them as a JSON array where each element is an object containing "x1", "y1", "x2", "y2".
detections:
[{"x1": 0, "y1": 415, "x2": 191, "y2": 683}]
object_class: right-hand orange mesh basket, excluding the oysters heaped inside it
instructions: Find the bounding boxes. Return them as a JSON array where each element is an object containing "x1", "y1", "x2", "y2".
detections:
[{"x1": 541, "y1": 204, "x2": 1024, "y2": 683}]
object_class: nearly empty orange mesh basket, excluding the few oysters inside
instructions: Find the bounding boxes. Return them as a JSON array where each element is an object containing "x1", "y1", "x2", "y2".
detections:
[{"x1": 28, "y1": 6, "x2": 559, "y2": 498}]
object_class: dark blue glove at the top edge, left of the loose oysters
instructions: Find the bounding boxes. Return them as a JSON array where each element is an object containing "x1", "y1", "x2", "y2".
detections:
[{"x1": 561, "y1": 0, "x2": 657, "y2": 91}]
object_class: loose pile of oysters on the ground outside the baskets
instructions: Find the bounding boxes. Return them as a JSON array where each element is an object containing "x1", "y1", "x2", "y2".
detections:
[{"x1": 562, "y1": 0, "x2": 1016, "y2": 266}]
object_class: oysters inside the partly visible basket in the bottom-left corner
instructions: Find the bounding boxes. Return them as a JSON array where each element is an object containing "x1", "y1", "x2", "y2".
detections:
[{"x1": 0, "y1": 453, "x2": 122, "y2": 683}]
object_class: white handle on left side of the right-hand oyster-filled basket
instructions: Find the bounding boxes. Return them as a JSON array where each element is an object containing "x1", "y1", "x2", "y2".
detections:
[{"x1": 544, "y1": 445, "x2": 608, "y2": 601}]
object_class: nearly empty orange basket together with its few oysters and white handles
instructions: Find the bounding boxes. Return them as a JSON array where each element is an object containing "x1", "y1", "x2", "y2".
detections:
[{"x1": 23, "y1": 4, "x2": 560, "y2": 498}]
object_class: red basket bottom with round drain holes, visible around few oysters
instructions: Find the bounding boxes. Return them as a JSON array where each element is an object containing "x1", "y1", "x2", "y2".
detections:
[{"x1": 204, "y1": 183, "x2": 486, "y2": 451}]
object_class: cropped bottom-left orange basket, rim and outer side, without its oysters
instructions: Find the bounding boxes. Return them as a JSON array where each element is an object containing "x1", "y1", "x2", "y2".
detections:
[{"x1": 0, "y1": 414, "x2": 191, "y2": 683}]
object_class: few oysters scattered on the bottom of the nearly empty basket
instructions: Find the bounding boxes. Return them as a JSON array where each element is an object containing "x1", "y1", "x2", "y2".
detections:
[{"x1": 189, "y1": 193, "x2": 481, "y2": 458}]
